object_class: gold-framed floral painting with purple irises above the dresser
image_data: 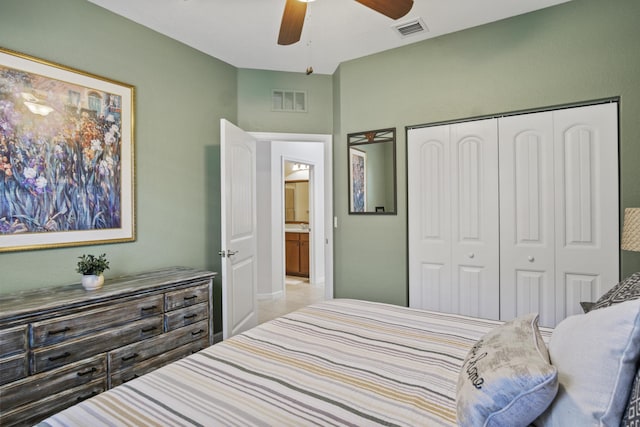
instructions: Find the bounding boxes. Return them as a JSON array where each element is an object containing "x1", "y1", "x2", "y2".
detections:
[{"x1": 0, "y1": 48, "x2": 135, "y2": 252}]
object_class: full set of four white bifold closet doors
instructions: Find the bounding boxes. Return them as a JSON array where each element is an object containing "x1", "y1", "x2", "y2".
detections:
[{"x1": 407, "y1": 103, "x2": 619, "y2": 326}]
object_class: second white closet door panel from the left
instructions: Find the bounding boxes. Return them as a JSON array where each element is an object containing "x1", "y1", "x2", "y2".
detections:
[{"x1": 451, "y1": 119, "x2": 500, "y2": 319}]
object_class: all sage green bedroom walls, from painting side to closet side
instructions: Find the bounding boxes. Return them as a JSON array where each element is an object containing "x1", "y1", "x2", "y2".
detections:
[{"x1": 0, "y1": 0, "x2": 640, "y2": 322}]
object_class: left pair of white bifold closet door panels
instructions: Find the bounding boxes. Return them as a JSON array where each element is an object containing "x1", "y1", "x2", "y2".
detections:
[{"x1": 407, "y1": 119, "x2": 499, "y2": 319}]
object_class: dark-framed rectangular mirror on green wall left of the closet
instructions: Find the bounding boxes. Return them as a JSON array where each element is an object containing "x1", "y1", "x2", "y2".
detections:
[{"x1": 347, "y1": 128, "x2": 396, "y2": 215}]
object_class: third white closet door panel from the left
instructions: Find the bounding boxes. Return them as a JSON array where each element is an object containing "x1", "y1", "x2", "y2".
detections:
[{"x1": 499, "y1": 111, "x2": 556, "y2": 326}]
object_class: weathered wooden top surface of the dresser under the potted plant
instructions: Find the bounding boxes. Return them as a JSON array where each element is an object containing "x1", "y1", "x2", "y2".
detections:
[{"x1": 0, "y1": 267, "x2": 216, "y2": 324}]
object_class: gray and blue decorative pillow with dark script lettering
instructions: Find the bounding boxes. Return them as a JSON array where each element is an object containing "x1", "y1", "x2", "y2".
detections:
[{"x1": 457, "y1": 314, "x2": 558, "y2": 427}]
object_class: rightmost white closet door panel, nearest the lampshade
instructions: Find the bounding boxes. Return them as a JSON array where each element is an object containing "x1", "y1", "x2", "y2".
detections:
[{"x1": 554, "y1": 103, "x2": 619, "y2": 321}]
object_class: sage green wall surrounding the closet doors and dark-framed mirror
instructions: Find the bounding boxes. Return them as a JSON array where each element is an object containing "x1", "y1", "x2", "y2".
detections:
[{"x1": 334, "y1": 0, "x2": 640, "y2": 305}]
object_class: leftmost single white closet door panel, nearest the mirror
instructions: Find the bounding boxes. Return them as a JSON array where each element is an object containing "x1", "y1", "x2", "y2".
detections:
[{"x1": 407, "y1": 125, "x2": 454, "y2": 312}]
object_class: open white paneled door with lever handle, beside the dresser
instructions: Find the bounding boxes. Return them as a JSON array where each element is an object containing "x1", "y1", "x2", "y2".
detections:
[{"x1": 220, "y1": 119, "x2": 258, "y2": 339}]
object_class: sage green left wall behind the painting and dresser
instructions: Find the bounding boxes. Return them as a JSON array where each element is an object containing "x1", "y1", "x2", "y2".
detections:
[{"x1": 0, "y1": 0, "x2": 237, "y2": 330}]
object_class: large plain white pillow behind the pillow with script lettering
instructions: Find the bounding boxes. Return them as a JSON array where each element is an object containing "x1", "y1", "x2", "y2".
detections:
[{"x1": 535, "y1": 300, "x2": 640, "y2": 427}]
